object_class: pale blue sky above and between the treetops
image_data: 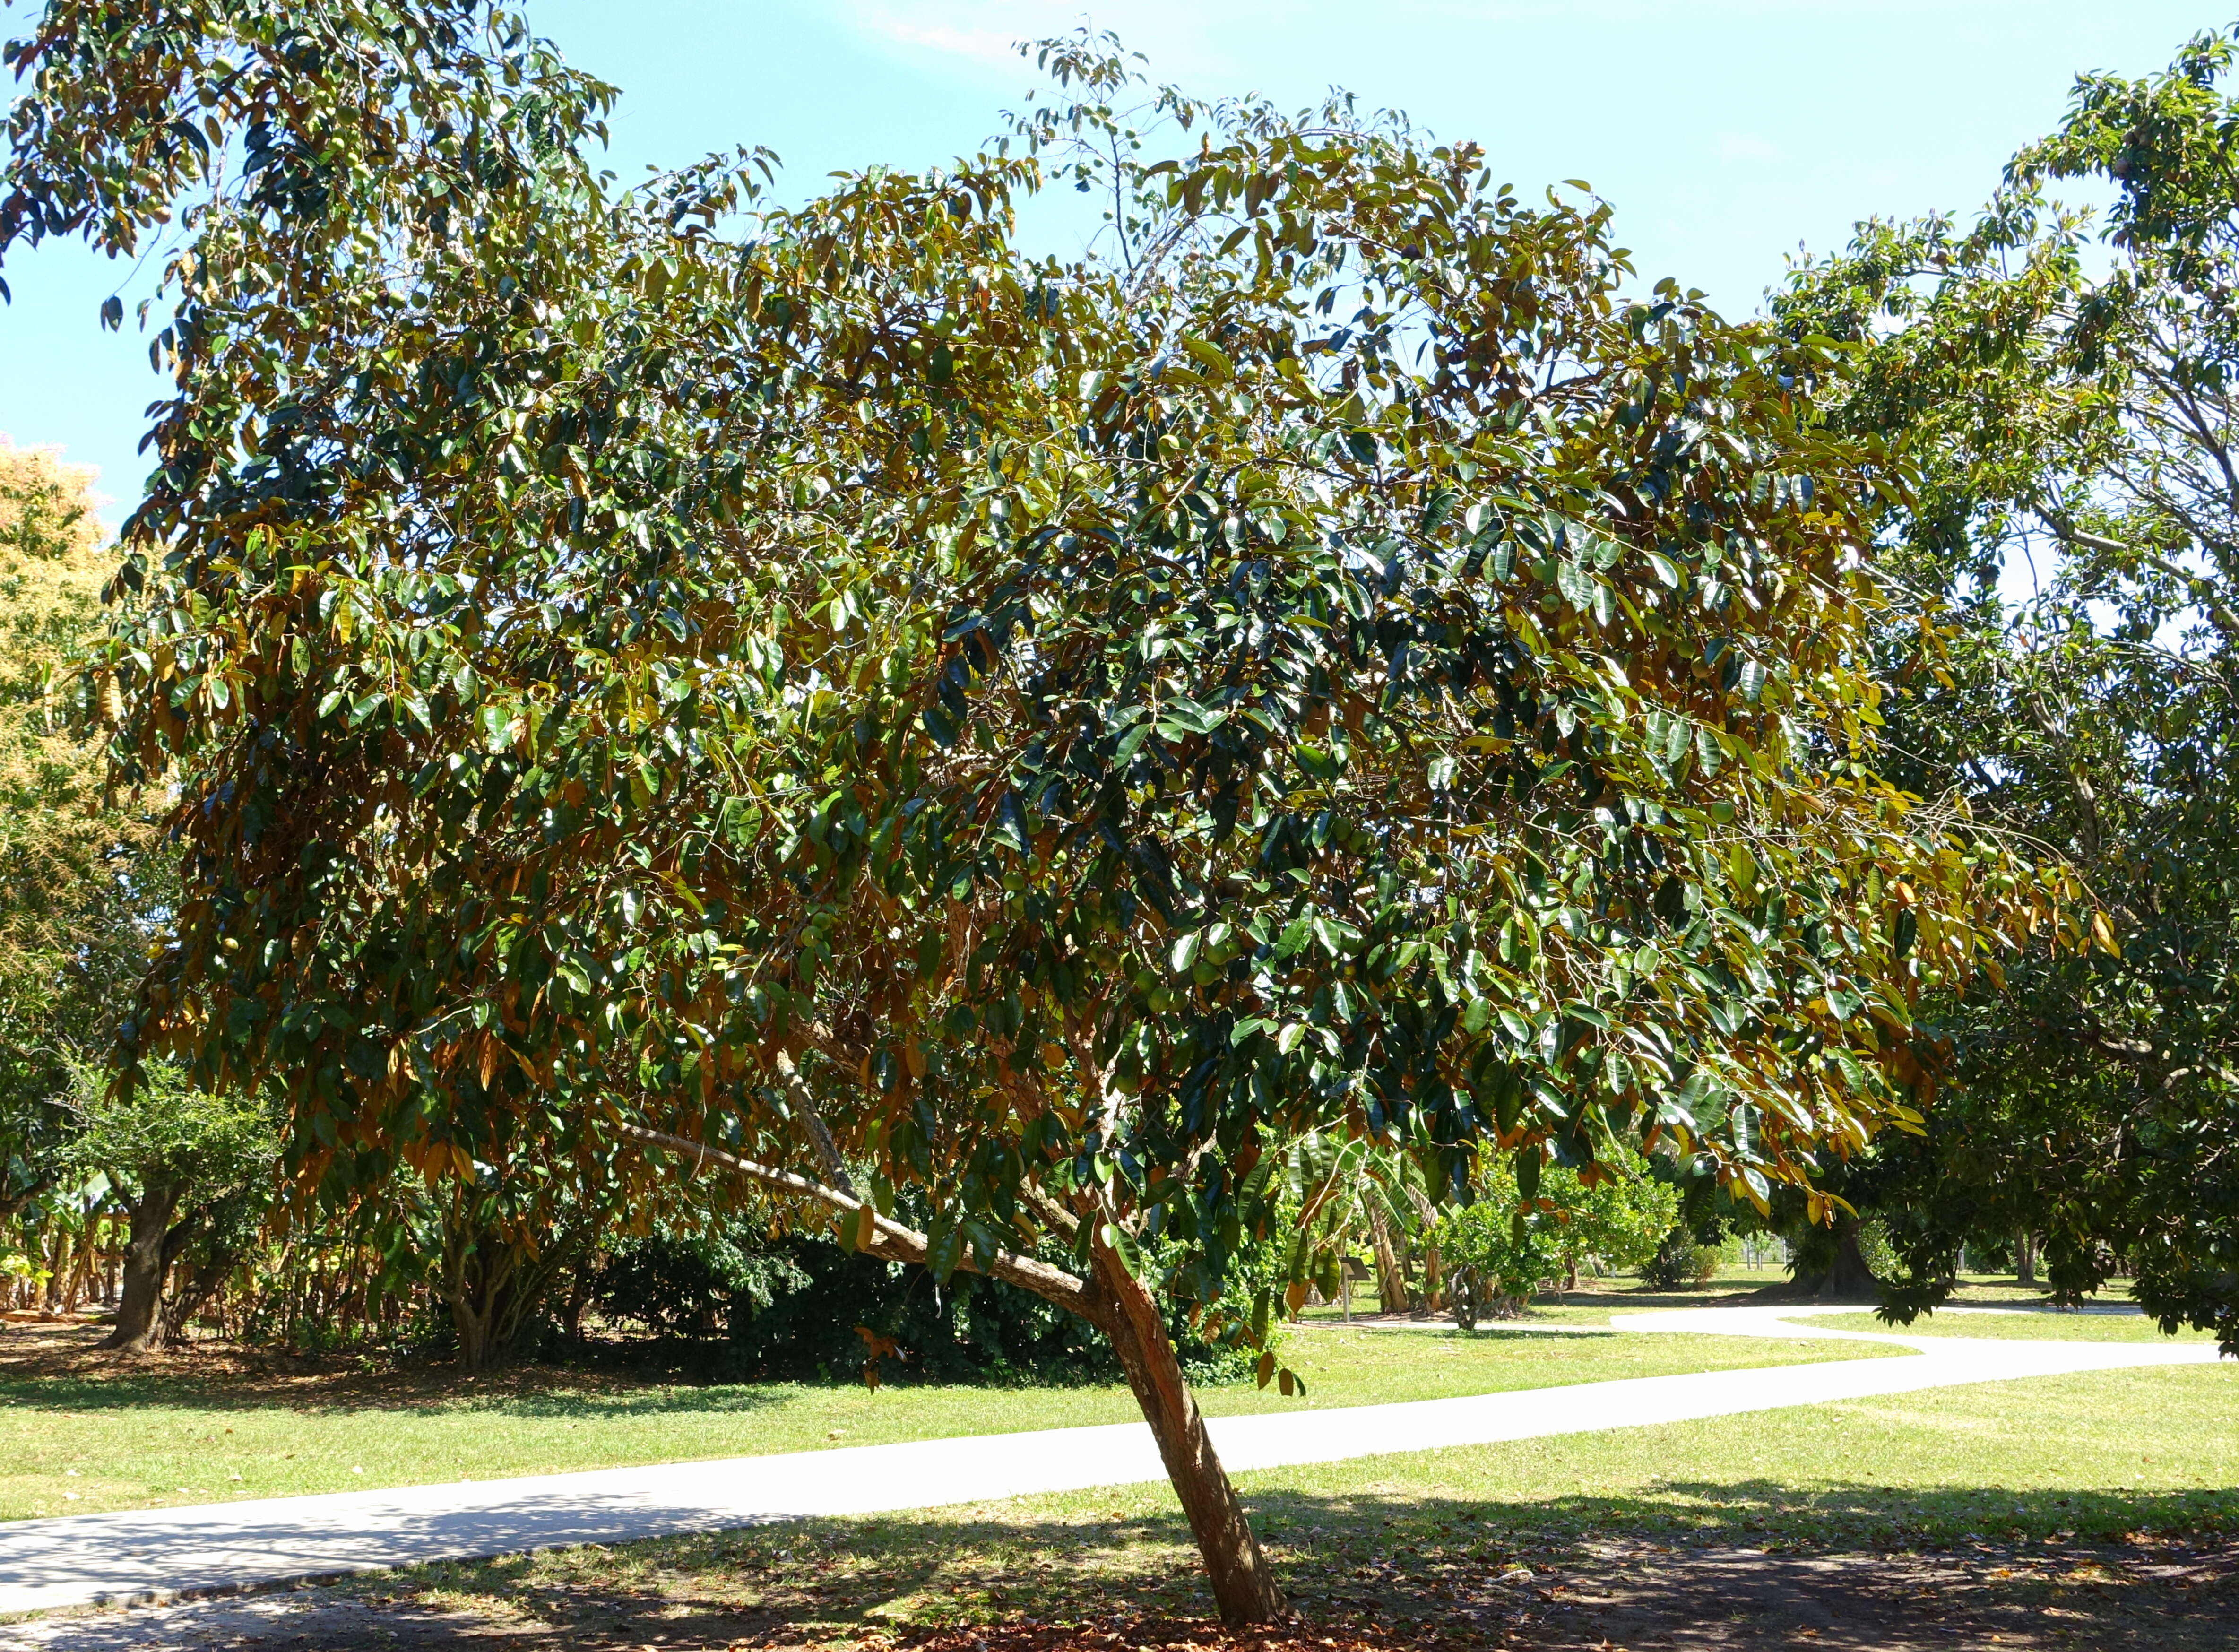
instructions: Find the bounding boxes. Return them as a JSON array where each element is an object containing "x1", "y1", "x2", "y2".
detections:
[{"x1": 0, "y1": 0, "x2": 2212, "y2": 521}]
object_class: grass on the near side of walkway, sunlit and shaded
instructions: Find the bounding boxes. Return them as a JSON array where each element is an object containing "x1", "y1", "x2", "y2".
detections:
[{"x1": 389, "y1": 1366, "x2": 2239, "y2": 1645}]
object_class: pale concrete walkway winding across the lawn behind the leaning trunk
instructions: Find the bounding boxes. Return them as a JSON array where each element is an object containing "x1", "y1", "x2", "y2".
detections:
[{"x1": 0, "y1": 1307, "x2": 2217, "y2": 1614}]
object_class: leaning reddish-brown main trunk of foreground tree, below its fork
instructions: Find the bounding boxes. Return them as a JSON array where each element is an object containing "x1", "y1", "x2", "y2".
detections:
[{"x1": 1090, "y1": 1236, "x2": 1285, "y2": 1625}]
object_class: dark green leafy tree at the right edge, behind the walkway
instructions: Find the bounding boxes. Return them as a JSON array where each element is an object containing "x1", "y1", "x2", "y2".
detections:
[{"x1": 1780, "y1": 31, "x2": 2239, "y2": 1348}]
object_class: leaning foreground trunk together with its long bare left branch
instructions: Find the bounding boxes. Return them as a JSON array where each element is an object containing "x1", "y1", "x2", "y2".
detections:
[{"x1": 622, "y1": 1126, "x2": 1288, "y2": 1625}]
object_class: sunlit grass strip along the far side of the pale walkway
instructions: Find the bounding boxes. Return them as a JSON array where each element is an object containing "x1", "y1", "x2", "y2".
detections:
[{"x1": 0, "y1": 1327, "x2": 1905, "y2": 1520}]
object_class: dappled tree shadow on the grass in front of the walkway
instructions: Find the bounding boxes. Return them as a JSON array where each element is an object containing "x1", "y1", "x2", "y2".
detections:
[{"x1": 367, "y1": 1479, "x2": 2239, "y2": 1645}]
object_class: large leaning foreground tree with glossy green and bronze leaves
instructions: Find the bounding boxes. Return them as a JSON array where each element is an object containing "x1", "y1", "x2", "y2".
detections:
[{"x1": 0, "y1": 0, "x2": 2056, "y2": 1621}]
